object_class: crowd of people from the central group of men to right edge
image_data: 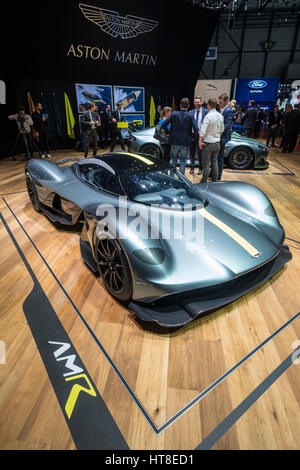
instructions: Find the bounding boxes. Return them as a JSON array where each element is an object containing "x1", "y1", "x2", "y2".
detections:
[{"x1": 157, "y1": 93, "x2": 300, "y2": 182}]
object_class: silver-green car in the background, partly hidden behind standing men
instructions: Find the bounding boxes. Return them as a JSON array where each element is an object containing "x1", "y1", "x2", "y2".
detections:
[{"x1": 128, "y1": 127, "x2": 269, "y2": 170}]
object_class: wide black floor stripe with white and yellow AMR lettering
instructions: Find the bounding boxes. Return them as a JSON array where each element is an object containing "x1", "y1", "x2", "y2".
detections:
[{"x1": 0, "y1": 212, "x2": 128, "y2": 450}]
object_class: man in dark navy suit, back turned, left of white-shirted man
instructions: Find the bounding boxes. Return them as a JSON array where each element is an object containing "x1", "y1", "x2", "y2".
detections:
[{"x1": 161, "y1": 98, "x2": 199, "y2": 175}]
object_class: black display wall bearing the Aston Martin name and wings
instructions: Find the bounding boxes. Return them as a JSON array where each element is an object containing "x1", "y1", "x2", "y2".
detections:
[{"x1": 0, "y1": 0, "x2": 218, "y2": 155}]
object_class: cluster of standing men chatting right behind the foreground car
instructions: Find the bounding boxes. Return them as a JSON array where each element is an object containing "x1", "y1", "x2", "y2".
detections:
[{"x1": 158, "y1": 93, "x2": 233, "y2": 182}]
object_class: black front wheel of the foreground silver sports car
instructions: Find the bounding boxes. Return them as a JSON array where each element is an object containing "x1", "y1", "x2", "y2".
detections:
[{"x1": 95, "y1": 235, "x2": 132, "y2": 302}]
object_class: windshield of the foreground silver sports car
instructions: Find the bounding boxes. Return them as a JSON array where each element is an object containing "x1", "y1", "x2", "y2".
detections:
[{"x1": 120, "y1": 167, "x2": 205, "y2": 210}]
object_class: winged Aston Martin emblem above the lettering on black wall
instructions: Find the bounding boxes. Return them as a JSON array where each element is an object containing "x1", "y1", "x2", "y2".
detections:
[{"x1": 79, "y1": 3, "x2": 159, "y2": 39}]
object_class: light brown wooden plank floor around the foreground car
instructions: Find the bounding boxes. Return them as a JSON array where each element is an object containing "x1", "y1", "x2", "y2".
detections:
[{"x1": 0, "y1": 141, "x2": 300, "y2": 449}]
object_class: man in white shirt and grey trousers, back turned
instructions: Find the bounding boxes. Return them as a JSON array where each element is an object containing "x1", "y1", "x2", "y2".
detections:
[{"x1": 199, "y1": 98, "x2": 224, "y2": 183}]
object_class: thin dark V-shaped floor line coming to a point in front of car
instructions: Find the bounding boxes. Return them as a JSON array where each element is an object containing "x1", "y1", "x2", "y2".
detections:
[{"x1": 2, "y1": 197, "x2": 300, "y2": 435}]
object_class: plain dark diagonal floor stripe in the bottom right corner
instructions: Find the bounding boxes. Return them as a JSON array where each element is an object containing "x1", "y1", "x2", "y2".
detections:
[{"x1": 195, "y1": 351, "x2": 300, "y2": 450}]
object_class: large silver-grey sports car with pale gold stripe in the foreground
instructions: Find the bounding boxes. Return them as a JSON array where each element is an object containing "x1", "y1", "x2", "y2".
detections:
[{"x1": 25, "y1": 152, "x2": 291, "y2": 327}]
